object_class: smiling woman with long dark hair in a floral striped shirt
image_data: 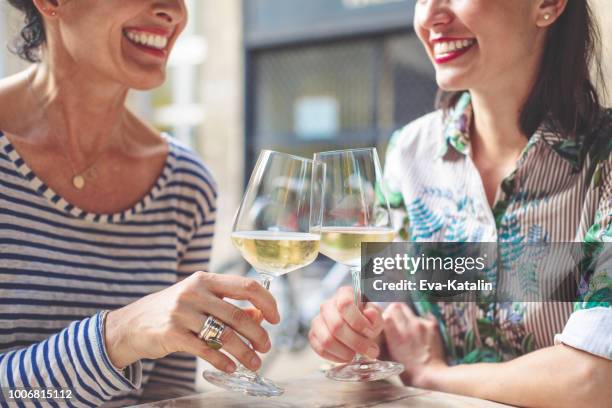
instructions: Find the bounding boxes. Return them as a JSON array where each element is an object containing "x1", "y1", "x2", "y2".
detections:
[{"x1": 310, "y1": 0, "x2": 612, "y2": 407}]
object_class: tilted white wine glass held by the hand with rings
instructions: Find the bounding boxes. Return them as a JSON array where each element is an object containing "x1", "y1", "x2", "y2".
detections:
[{"x1": 203, "y1": 150, "x2": 320, "y2": 397}]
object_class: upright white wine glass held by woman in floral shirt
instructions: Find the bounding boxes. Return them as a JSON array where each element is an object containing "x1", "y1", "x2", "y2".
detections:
[{"x1": 311, "y1": 148, "x2": 404, "y2": 381}]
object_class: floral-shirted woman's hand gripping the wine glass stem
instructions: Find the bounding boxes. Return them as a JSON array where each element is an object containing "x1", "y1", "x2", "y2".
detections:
[{"x1": 308, "y1": 287, "x2": 383, "y2": 363}]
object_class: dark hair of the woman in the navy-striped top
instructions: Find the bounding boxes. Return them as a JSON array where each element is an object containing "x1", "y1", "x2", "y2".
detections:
[{"x1": 8, "y1": 0, "x2": 45, "y2": 62}]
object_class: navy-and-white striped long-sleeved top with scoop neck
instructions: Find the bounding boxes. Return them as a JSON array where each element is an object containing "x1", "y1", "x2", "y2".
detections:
[{"x1": 0, "y1": 132, "x2": 216, "y2": 406}]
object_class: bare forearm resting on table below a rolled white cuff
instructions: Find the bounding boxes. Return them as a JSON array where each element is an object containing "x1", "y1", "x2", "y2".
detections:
[{"x1": 412, "y1": 345, "x2": 612, "y2": 407}]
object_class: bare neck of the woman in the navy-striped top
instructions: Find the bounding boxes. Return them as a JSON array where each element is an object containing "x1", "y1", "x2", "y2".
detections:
[{"x1": 29, "y1": 63, "x2": 128, "y2": 163}]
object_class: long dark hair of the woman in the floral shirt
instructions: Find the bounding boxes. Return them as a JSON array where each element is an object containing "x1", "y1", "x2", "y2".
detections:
[{"x1": 436, "y1": 0, "x2": 605, "y2": 142}]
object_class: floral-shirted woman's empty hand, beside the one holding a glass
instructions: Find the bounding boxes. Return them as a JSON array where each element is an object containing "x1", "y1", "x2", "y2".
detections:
[{"x1": 383, "y1": 303, "x2": 447, "y2": 388}]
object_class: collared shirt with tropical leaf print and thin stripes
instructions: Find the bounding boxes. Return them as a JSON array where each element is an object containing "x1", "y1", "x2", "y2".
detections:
[{"x1": 385, "y1": 92, "x2": 612, "y2": 363}]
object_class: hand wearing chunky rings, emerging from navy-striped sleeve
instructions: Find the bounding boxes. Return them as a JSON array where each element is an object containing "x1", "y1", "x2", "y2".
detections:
[{"x1": 105, "y1": 272, "x2": 280, "y2": 372}]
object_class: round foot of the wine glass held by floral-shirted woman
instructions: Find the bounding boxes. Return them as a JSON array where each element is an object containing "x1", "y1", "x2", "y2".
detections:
[{"x1": 326, "y1": 359, "x2": 404, "y2": 381}]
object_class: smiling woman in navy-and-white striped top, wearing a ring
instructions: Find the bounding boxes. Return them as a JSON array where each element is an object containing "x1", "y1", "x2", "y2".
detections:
[{"x1": 0, "y1": 0, "x2": 279, "y2": 406}]
